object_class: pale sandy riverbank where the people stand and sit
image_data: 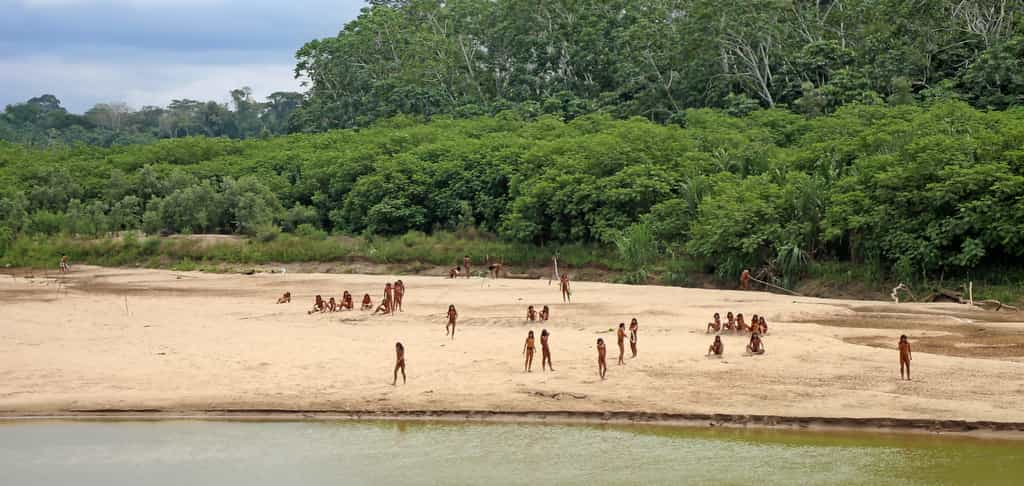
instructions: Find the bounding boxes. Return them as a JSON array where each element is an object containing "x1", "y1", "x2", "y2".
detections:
[{"x1": 0, "y1": 267, "x2": 1024, "y2": 423}]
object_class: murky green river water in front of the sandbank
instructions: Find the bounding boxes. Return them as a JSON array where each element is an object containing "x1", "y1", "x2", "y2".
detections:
[{"x1": 0, "y1": 421, "x2": 1024, "y2": 486}]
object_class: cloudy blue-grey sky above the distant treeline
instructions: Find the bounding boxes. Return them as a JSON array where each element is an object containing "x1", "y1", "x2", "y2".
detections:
[{"x1": 0, "y1": 0, "x2": 364, "y2": 113}]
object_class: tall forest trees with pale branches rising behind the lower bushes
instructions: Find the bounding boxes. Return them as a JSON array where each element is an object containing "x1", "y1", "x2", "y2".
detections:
[{"x1": 294, "y1": 0, "x2": 1024, "y2": 131}]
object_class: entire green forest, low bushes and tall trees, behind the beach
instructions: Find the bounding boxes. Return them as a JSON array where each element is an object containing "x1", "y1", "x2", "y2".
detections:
[{"x1": 0, "y1": 0, "x2": 1024, "y2": 290}]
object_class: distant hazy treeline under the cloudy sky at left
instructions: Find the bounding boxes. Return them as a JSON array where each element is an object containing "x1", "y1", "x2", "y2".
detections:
[{"x1": 0, "y1": 88, "x2": 302, "y2": 146}]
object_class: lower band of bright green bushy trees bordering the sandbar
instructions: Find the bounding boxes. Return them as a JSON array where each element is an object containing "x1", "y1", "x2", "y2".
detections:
[{"x1": 0, "y1": 100, "x2": 1024, "y2": 290}]
